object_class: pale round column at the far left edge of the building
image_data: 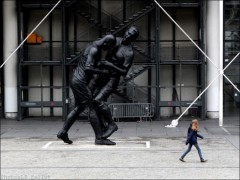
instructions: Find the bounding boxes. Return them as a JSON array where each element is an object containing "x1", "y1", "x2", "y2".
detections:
[{"x1": 3, "y1": 0, "x2": 18, "y2": 118}]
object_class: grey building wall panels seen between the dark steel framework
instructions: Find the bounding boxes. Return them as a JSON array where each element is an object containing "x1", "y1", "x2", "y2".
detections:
[{"x1": 25, "y1": 1, "x2": 198, "y2": 116}]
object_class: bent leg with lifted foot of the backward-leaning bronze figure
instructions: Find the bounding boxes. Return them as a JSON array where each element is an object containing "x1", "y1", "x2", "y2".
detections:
[{"x1": 94, "y1": 79, "x2": 118, "y2": 138}]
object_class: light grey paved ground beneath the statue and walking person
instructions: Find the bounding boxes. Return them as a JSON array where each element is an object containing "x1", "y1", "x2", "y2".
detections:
[{"x1": 1, "y1": 118, "x2": 239, "y2": 179}]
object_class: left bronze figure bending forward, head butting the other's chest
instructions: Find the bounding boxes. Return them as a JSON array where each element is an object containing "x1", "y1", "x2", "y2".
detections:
[{"x1": 57, "y1": 35, "x2": 116, "y2": 144}]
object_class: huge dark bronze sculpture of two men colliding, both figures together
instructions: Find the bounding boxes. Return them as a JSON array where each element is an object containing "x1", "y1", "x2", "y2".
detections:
[{"x1": 57, "y1": 26, "x2": 139, "y2": 145}]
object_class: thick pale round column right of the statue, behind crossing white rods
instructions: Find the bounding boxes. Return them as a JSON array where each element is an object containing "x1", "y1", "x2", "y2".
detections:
[{"x1": 206, "y1": 0, "x2": 223, "y2": 118}]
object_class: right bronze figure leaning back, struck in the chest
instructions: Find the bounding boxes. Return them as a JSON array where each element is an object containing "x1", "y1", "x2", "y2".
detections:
[{"x1": 93, "y1": 26, "x2": 139, "y2": 138}]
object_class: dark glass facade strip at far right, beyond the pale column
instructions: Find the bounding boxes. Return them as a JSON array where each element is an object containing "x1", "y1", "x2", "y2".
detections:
[{"x1": 223, "y1": 0, "x2": 240, "y2": 117}]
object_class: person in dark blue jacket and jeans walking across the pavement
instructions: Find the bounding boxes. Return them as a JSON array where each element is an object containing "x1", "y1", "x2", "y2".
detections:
[{"x1": 179, "y1": 119, "x2": 207, "y2": 162}]
